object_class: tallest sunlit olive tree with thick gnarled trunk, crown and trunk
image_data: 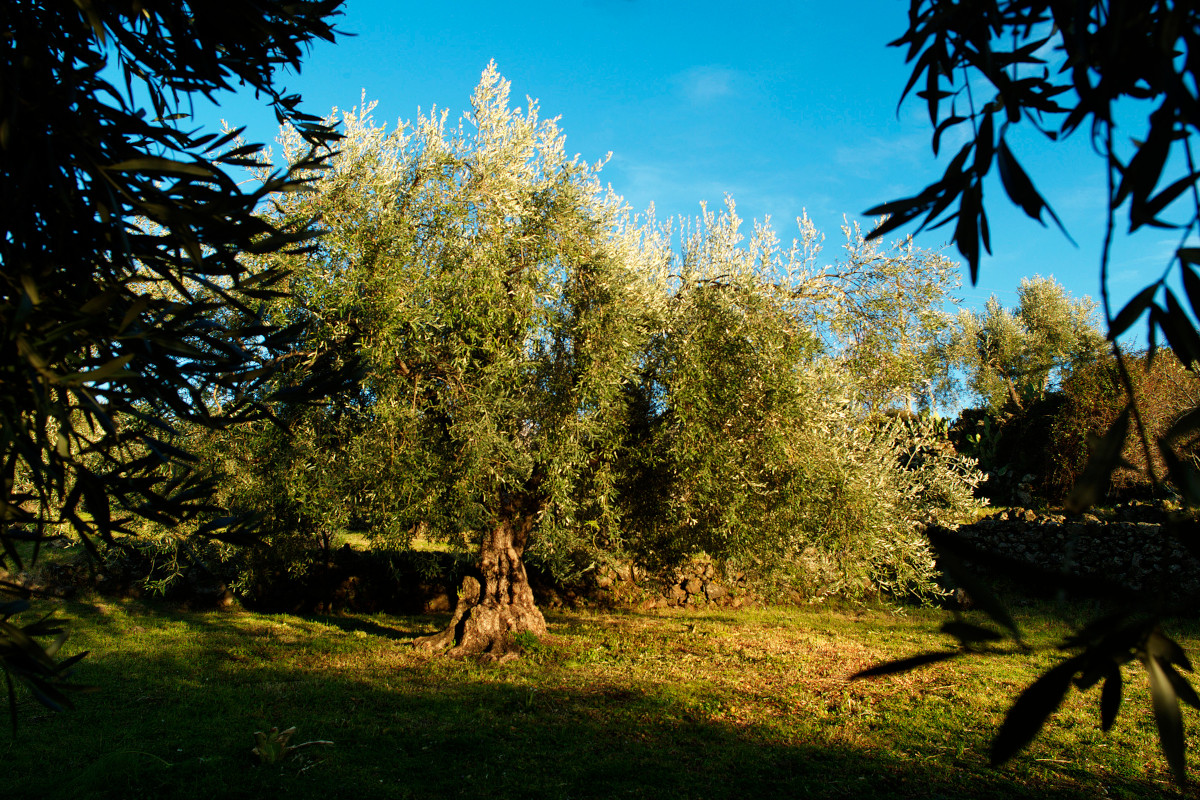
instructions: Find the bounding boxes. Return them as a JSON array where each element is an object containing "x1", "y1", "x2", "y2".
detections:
[{"x1": 256, "y1": 64, "x2": 661, "y2": 655}]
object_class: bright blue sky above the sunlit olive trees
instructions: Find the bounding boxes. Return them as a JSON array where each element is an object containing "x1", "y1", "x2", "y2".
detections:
[{"x1": 194, "y1": 0, "x2": 1177, "y2": 331}]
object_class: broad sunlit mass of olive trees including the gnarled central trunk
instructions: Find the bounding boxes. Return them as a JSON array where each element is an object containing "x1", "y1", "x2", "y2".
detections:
[{"x1": 157, "y1": 59, "x2": 977, "y2": 656}]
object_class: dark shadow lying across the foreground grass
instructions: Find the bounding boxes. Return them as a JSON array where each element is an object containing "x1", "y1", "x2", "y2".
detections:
[{"x1": 2, "y1": 604, "x2": 1165, "y2": 800}]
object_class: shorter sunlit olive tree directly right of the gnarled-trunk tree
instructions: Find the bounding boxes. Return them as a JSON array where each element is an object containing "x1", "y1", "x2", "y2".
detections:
[{"x1": 622, "y1": 200, "x2": 977, "y2": 597}]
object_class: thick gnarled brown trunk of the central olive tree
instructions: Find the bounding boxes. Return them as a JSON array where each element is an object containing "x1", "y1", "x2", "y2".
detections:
[{"x1": 413, "y1": 493, "x2": 546, "y2": 660}]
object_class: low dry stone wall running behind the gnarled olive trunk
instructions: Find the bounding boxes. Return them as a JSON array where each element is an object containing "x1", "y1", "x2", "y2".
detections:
[{"x1": 23, "y1": 504, "x2": 1200, "y2": 614}]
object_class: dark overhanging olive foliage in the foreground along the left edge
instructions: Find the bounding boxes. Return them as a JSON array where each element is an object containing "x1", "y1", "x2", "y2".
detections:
[{"x1": 0, "y1": 0, "x2": 340, "y2": 724}]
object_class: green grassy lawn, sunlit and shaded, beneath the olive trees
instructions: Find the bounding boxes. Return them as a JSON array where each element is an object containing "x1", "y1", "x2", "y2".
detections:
[{"x1": 0, "y1": 600, "x2": 1200, "y2": 800}]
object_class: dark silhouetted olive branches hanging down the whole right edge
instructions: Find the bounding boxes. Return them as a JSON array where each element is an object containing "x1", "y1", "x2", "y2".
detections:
[{"x1": 870, "y1": 0, "x2": 1200, "y2": 783}]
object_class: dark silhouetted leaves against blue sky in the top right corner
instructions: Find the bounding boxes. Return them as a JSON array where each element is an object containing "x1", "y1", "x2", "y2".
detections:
[{"x1": 869, "y1": 0, "x2": 1200, "y2": 303}]
